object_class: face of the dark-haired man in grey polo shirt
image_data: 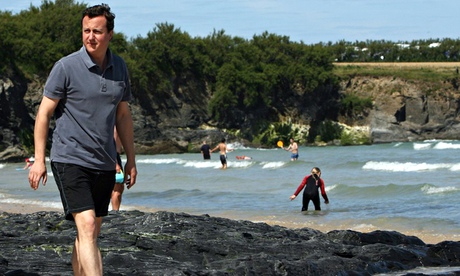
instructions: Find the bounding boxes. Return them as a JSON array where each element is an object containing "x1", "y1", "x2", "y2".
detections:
[{"x1": 82, "y1": 15, "x2": 113, "y2": 58}]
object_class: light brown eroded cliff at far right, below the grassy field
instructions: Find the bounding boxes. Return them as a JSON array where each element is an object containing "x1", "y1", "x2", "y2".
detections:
[{"x1": 342, "y1": 77, "x2": 460, "y2": 143}]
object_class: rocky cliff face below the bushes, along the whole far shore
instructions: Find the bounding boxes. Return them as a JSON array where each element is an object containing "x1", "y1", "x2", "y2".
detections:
[{"x1": 0, "y1": 76, "x2": 460, "y2": 161}]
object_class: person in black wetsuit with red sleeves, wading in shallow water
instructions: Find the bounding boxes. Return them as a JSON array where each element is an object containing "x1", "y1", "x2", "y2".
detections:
[{"x1": 290, "y1": 167, "x2": 329, "y2": 211}]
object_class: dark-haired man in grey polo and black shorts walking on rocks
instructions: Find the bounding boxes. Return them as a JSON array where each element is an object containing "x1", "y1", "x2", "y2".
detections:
[{"x1": 29, "y1": 4, "x2": 137, "y2": 275}]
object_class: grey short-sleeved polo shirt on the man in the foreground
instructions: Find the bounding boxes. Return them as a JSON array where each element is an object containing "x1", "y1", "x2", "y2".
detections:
[{"x1": 44, "y1": 46, "x2": 131, "y2": 170}]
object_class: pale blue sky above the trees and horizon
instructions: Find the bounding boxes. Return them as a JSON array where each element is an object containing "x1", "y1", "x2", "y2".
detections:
[{"x1": 4, "y1": 0, "x2": 460, "y2": 44}]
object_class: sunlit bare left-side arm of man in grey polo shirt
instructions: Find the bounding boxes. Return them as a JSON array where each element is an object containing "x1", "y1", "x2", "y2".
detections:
[{"x1": 29, "y1": 96, "x2": 59, "y2": 190}]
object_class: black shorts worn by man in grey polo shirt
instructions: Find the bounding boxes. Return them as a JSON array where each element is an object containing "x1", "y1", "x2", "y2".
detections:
[{"x1": 51, "y1": 162, "x2": 115, "y2": 220}]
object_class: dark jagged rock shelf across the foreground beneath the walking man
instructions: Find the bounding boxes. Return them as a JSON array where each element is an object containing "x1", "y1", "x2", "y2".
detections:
[{"x1": 0, "y1": 211, "x2": 460, "y2": 275}]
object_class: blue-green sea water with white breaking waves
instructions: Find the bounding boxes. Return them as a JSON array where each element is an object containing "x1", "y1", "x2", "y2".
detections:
[{"x1": 0, "y1": 140, "x2": 460, "y2": 243}]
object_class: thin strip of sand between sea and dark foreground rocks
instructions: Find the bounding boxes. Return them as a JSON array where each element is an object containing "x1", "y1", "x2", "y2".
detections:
[{"x1": 0, "y1": 202, "x2": 460, "y2": 244}]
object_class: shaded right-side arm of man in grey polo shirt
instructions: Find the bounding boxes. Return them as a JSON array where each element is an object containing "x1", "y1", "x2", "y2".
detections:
[{"x1": 116, "y1": 102, "x2": 137, "y2": 189}]
